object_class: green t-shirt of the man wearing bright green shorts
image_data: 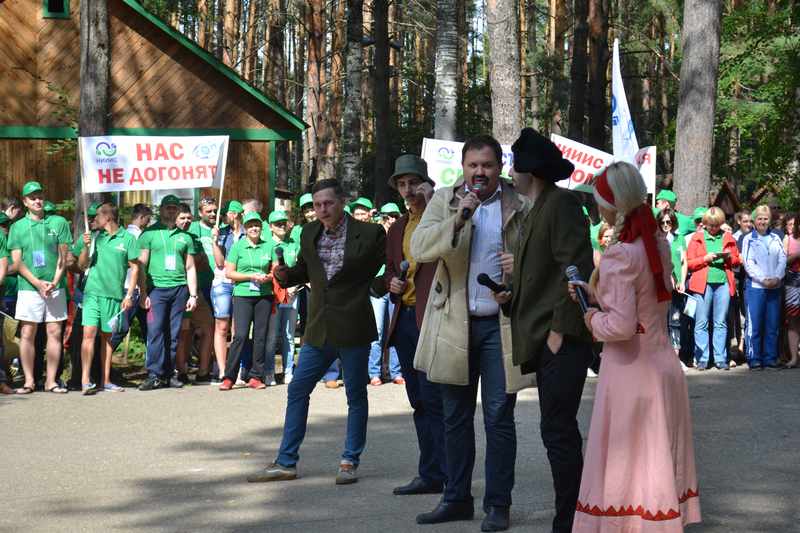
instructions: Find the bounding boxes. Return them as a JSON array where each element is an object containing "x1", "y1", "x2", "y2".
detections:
[{"x1": 75, "y1": 228, "x2": 139, "y2": 301}]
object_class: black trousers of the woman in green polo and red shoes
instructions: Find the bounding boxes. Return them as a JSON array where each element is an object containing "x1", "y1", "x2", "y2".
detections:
[{"x1": 225, "y1": 296, "x2": 275, "y2": 381}]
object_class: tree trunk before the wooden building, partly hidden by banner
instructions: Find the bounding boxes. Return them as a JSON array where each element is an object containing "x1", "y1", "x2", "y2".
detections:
[{"x1": 73, "y1": 0, "x2": 111, "y2": 228}]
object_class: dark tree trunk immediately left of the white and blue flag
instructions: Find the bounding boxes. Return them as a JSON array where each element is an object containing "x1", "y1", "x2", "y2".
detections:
[{"x1": 589, "y1": 0, "x2": 609, "y2": 150}]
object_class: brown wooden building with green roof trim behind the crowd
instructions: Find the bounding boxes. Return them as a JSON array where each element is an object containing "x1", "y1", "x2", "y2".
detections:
[{"x1": 0, "y1": 0, "x2": 306, "y2": 209}]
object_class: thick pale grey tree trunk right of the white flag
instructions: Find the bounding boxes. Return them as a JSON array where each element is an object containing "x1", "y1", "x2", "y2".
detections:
[{"x1": 674, "y1": 0, "x2": 720, "y2": 213}]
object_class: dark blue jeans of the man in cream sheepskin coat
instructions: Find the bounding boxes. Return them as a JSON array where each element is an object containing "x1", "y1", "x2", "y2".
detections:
[{"x1": 440, "y1": 316, "x2": 516, "y2": 510}]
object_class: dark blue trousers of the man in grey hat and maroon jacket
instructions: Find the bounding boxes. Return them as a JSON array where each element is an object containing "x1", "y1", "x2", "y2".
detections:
[{"x1": 393, "y1": 306, "x2": 446, "y2": 484}]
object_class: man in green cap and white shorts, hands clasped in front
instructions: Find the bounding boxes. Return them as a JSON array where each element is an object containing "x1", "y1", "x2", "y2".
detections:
[{"x1": 8, "y1": 181, "x2": 72, "y2": 394}]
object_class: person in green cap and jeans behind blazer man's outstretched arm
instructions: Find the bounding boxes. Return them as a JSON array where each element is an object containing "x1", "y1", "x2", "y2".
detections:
[{"x1": 267, "y1": 211, "x2": 300, "y2": 385}]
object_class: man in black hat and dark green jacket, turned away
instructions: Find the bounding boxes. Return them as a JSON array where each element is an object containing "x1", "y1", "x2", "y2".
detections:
[{"x1": 511, "y1": 128, "x2": 592, "y2": 533}]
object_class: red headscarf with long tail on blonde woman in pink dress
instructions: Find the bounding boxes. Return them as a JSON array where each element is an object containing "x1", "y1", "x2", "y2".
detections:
[{"x1": 595, "y1": 172, "x2": 672, "y2": 302}]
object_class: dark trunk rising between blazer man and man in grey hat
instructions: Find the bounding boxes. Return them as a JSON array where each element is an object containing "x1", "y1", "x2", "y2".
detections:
[{"x1": 372, "y1": 1, "x2": 392, "y2": 204}]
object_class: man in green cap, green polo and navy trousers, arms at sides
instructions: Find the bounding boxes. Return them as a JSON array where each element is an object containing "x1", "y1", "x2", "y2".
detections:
[{"x1": 139, "y1": 194, "x2": 197, "y2": 391}]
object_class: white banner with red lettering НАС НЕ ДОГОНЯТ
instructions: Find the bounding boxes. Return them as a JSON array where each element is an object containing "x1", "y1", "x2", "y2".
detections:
[{"x1": 79, "y1": 135, "x2": 228, "y2": 193}]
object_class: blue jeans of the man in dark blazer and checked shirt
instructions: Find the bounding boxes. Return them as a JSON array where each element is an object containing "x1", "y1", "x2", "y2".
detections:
[{"x1": 275, "y1": 343, "x2": 369, "y2": 466}]
